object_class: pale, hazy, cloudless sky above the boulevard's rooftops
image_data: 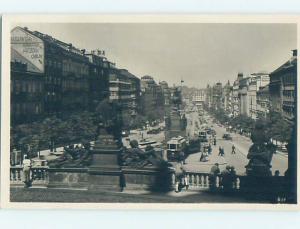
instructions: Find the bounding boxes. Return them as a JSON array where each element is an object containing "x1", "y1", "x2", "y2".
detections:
[{"x1": 15, "y1": 23, "x2": 297, "y2": 88}]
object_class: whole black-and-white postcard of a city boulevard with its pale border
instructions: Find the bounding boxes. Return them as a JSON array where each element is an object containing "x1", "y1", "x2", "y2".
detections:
[{"x1": 1, "y1": 16, "x2": 299, "y2": 209}]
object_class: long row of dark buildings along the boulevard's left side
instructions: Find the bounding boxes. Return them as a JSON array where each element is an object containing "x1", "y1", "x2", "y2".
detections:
[{"x1": 11, "y1": 27, "x2": 170, "y2": 125}]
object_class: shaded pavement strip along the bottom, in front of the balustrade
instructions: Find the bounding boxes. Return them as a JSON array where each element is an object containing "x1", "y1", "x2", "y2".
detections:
[{"x1": 10, "y1": 188, "x2": 250, "y2": 203}]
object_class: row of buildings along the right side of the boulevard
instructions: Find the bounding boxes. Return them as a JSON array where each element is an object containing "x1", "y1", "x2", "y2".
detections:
[{"x1": 199, "y1": 50, "x2": 297, "y2": 122}]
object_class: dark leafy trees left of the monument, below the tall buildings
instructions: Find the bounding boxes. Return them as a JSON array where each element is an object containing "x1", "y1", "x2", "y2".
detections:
[{"x1": 10, "y1": 112, "x2": 97, "y2": 157}]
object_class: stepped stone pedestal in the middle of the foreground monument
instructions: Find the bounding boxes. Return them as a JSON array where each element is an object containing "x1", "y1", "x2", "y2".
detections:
[{"x1": 88, "y1": 132, "x2": 122, "y2": 191}]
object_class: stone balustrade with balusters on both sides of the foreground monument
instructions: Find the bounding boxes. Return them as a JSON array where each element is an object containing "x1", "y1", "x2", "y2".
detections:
[{"x1": 10, "y1": 166, "x2": 288, "y2": 203}]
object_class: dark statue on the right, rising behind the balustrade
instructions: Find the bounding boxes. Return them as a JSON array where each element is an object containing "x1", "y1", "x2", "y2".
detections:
[{"x1": 246, "y1": 122, "x2": 276, "y2": 177}]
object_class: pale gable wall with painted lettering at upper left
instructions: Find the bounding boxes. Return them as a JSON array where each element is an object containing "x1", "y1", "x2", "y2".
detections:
[{"x1": 11, "y1": 27, "x2": 45, "y2": 73}]
